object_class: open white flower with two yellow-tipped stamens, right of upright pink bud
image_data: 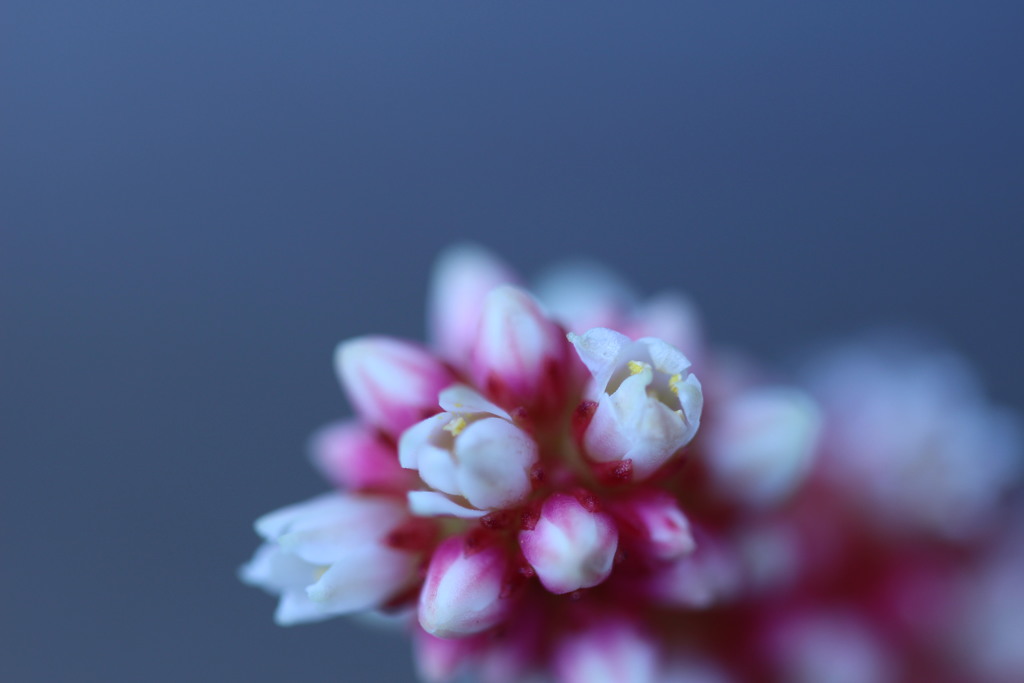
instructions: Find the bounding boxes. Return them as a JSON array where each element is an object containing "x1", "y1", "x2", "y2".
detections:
[{"x1": 569, "y1": 328, "x2": 703, "y2": 479}]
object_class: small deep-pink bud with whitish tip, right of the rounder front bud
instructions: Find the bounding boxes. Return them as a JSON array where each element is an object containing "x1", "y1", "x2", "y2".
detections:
[{"x1": 614, "y1": 490, "x2": 696, "y2": 560}]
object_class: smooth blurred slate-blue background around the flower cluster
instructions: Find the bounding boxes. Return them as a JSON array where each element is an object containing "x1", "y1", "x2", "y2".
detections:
[{"x1": 0, "y1": 0, "x2": 1024, "y2": 682}]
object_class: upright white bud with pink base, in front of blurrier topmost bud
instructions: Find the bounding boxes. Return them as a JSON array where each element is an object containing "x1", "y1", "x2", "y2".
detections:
[{"x1": 472, "y1": 286, "x2": 566, "y2": 409}]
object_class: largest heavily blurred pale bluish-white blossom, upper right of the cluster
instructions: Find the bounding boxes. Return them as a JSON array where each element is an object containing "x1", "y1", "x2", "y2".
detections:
[{"x1": 810, "y1": 339, "x2": 1024, "y2": 540}]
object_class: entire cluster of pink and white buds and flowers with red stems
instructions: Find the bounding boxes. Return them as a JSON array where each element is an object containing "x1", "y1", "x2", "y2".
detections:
[{"x1": 242, "y1": 247, "x2": 1024, "y2": 683}]
